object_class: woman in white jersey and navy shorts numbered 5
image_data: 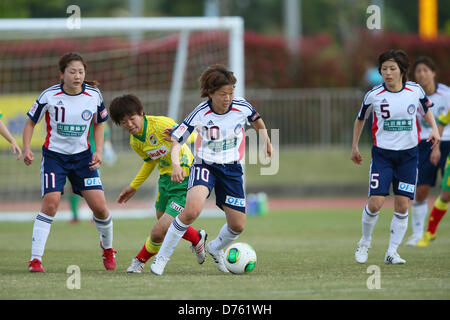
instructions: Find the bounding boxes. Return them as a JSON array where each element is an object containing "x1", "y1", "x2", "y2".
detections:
[{"x1": 351, "y1": 50, "x2": 440, "y2": 264}]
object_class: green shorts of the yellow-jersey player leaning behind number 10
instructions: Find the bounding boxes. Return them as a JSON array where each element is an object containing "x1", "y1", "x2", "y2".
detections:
[{"x1": 155, "y1": 174, "x2": 189, "y2": 218}]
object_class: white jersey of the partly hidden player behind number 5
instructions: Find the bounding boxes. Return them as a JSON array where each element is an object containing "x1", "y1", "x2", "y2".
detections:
[{"x1": 418, "y1": 83, "x2": 450, "y2": 141}]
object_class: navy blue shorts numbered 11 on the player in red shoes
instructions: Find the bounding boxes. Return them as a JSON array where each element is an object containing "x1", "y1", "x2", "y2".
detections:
[{"x1": 41, "y1": 147, "x2": 103, "y2": 196}]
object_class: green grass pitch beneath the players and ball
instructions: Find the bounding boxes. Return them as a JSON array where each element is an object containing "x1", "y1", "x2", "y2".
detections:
[{"x1": 0, "y1": 208, "x2": 450, "y2": 300}]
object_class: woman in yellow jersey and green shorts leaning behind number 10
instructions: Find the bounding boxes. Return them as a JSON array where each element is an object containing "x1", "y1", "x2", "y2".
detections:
[{"x1": 109, "y1": 94, "x2": 207, "y2": 273}]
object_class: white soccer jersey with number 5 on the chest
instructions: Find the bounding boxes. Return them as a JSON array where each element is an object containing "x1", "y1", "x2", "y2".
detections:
[{"x1": 358, "y1": 82, "x2": 433, "y2": 150}]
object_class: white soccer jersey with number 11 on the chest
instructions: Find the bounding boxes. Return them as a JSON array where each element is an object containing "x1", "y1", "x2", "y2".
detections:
[{"x1": 27, "y1": 83, "x2": 109, "y2": 154}]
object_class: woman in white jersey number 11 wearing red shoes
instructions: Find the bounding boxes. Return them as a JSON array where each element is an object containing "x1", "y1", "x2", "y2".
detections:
[{"x1": 23, "y1": 53, "x2": 116, "y2": 272}]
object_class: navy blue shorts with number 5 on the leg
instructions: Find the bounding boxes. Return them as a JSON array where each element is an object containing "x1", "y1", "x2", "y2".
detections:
[{"x1": 369, "y1": 146, "x2": 418, "y2": 199}]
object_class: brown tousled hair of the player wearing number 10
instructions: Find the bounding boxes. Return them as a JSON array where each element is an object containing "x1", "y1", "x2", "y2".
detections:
[{"x1": 199, "y1": 64, "x2": 237, "y2": 97}]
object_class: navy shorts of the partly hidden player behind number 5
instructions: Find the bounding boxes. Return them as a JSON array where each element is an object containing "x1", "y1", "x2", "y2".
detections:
[{"x1": 417, "y1": 140, "x2": 450, "y2": 187}]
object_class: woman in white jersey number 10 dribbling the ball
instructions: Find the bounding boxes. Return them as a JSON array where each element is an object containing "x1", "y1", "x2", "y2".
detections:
[{"x1": 151, "y1": 65, "x2": 272, "y2": 275}]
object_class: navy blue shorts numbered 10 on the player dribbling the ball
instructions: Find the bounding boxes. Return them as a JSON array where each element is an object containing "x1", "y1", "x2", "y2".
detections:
[{"x1": 188, "y1": 162, "x2": 246, "y2": 213}]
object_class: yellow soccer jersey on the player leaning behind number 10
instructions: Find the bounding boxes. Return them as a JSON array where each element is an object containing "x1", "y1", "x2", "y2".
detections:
[{"x1": 130, "y1": 116, "x2": 197, "y2": 189}]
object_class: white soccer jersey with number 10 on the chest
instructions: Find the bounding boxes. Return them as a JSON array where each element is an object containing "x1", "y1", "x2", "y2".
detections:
[{"x1": 171, "y1": 98, "x2": 260, "y2": 164}]
